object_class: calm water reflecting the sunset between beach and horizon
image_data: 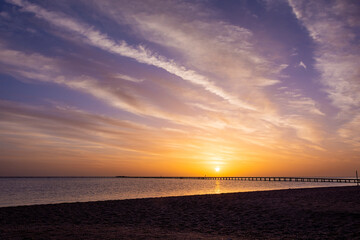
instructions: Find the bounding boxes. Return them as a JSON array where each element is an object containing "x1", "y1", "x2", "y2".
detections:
[{"x1": 0, "y1": 178, "x2": 354, "y2": 207}]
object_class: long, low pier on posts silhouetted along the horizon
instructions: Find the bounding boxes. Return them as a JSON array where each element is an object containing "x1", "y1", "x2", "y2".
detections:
[{"x1": 117, "y1": 176, "x2": 360, "y2": 184}]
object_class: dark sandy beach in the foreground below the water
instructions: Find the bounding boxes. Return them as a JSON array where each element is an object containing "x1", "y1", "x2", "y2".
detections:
[{"x1": 0, "y1": 186, "x2": 360, "y2": 239}]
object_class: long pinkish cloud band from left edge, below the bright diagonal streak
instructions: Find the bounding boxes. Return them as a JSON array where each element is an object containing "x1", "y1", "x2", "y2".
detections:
[{"x1": 0, "y1": 42, "x2": 278, "y2": 141}]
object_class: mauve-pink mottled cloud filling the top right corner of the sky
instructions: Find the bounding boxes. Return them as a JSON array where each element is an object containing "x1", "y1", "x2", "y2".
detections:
[{"x1": 289, "y1": 0, "x2": 360, "y2": 112}]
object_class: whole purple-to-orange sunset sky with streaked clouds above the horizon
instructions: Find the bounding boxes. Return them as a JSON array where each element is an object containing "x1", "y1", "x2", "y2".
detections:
[{"x1": 0, "y1": 0, "x2": 360, "y2": 176}]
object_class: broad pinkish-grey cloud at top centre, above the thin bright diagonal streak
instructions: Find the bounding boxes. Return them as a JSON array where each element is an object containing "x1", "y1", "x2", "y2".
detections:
[{"x1": 103, "y1": 1, "x2": 281, "y2": 90}]
